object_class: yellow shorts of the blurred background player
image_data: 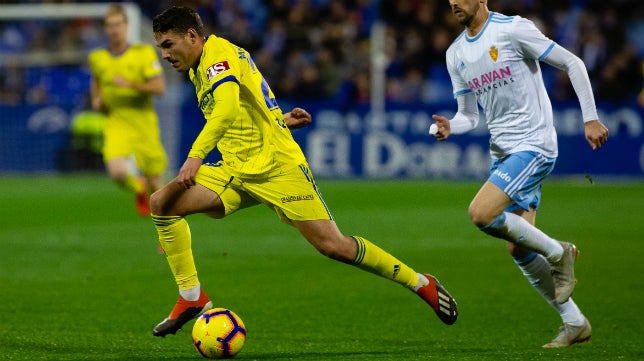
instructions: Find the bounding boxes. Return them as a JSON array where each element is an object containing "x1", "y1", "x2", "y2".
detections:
[{"x1": 103, "y1": 130, "x2": 168, "y2": 176}]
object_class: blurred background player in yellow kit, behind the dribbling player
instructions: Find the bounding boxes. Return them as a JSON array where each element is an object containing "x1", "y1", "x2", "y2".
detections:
[{"x1": 88, "y1": 5, "x2": 167, "y2": 216}]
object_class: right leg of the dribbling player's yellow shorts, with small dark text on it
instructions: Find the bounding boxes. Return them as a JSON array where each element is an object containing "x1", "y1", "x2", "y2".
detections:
[{"x1": 243, "y1": 164, "x2": 333, "y2": 224}]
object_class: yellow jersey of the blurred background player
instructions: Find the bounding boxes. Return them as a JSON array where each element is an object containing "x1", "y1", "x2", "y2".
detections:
[{"x1": 88, "y1": 44, "x2": 163, "y2": 141}]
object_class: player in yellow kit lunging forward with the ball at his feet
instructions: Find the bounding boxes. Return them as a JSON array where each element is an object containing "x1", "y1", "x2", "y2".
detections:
[{"x1": 150, "y1": 7, "x2": 457, "y2": 336}]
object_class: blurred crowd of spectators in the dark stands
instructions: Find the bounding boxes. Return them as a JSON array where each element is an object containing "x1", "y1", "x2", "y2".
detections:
[{"x1": 0, "y1": 0, "x2": 644, "y2": 108}]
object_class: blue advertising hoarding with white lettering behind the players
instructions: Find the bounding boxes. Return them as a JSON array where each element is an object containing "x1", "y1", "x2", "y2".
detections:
[{"x1": 0, "y1": 97, "x2": 644, "y2": 179}]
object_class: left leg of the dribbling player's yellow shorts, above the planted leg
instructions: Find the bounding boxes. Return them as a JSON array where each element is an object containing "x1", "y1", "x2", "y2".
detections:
[{"x1": 195, "y1": 162, "x2": 259, "y2": 216}]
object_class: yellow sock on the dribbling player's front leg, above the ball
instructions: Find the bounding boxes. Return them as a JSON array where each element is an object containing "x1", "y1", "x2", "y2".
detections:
[{"x1": 152, "y1": 215, "x2": 199, "y2": 290}]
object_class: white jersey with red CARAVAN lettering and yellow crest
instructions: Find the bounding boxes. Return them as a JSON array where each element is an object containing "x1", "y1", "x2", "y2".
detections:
[{"x1": 446, "y1": 12, "x2": 557, "y2": 158}]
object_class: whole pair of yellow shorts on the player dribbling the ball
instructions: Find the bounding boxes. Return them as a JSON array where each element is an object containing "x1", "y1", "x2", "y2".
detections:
[{"x1": 196, "y1": 162, "x2": 333, "y2": 224}]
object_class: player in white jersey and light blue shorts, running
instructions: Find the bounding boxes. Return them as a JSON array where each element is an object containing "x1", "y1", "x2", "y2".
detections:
[{"x1": 432, "y1": 0, "x2": 608, "y2": 348}]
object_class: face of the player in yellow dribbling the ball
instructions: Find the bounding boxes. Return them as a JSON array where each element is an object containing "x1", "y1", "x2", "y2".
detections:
[{"x1": 154, "y1": 30, "x2": 201, "y2": 72}]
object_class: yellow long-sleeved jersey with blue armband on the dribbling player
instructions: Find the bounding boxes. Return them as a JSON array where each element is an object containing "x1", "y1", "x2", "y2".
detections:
[{"x1": 188, "y1": 35, "x2": 306, "y2": 178}]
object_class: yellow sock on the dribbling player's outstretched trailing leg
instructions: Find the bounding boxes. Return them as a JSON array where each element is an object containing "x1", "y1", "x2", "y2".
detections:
[{"x1": 353, "y1": 236, "x2": 419, "y2": 290}]
